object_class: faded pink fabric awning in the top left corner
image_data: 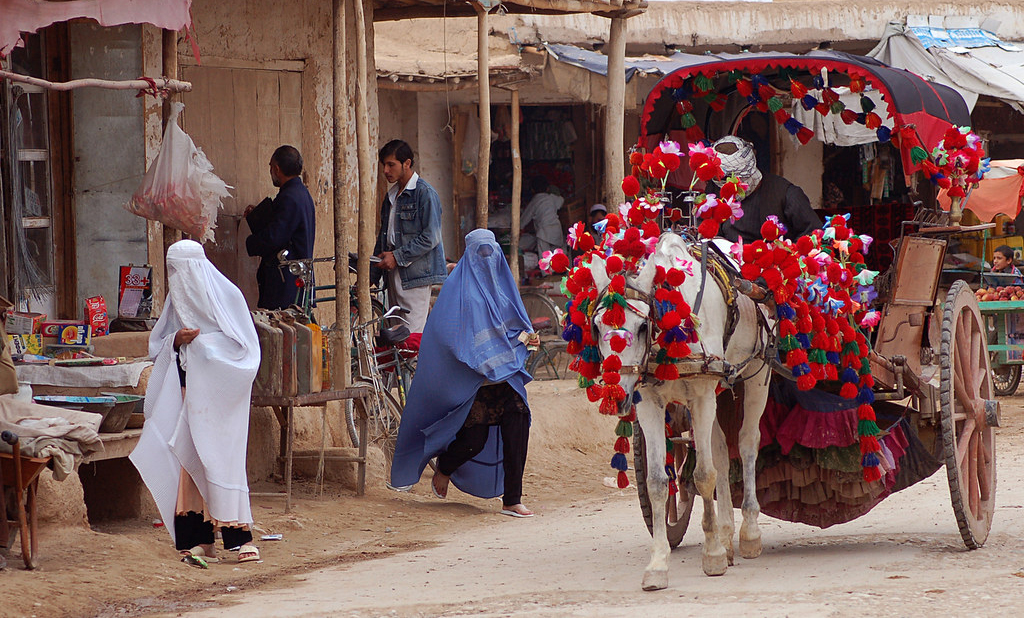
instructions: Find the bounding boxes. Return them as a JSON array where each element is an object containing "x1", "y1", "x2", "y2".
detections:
[{"x1": 0, "y1": 0, "x2": 191, "y2": 56}]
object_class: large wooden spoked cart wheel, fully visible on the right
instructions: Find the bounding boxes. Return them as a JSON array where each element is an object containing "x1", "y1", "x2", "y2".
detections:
[{"x1": 939, "y1": 280, "x2": 999, "y2": 549}]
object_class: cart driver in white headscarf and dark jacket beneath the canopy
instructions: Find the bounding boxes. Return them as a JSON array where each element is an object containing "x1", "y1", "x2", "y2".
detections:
[{"x1": 714, "y1": 135, "x2": 821, "y2": 242}]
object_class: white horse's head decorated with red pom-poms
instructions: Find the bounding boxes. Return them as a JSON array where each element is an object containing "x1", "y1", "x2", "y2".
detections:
[{"x1": 591, "y1": 253, "x2": 653, "y2": 414}]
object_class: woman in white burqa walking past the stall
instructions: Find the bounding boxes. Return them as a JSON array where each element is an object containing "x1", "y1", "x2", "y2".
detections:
[{"x1": 131, "y1": 240, "x2": 260, "y2": 562}]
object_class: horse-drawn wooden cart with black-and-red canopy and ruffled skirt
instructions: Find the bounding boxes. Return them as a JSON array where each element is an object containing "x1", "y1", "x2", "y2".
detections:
[{"x1": 614, "y1": 51, "x2": 999, "y2": 548}]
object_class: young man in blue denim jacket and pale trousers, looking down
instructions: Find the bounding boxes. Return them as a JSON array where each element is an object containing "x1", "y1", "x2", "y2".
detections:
[{"x1": 374, "y1": 139, "x2": 446, "y2": 333}]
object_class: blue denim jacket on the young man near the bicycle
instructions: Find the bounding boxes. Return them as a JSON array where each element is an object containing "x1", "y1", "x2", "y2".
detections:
[{"x1": 374, "y1": 177, "x2": 447, "y2": 290}]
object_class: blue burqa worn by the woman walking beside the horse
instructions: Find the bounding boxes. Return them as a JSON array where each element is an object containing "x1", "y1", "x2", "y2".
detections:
[{"x1": 391, "y1": 229, "x2": 532, "y2": 498}]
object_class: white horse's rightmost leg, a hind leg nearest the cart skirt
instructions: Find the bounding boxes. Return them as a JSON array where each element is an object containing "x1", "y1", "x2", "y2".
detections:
[{"x1": 739, "y1": 376, "x2": 768, "y2": 558}]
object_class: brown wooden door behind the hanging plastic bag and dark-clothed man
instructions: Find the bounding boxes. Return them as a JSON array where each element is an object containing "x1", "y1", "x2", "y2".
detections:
[{"x1": 182, "y1": 62, "x2": 302, "y2": 307}]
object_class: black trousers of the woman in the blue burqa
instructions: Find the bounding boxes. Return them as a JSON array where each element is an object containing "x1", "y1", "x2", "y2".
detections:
[{"x1": 437, "y1": 411, "x2": 529, "y2": 506}]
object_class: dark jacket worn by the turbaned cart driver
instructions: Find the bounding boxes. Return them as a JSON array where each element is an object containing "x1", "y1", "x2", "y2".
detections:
[{"x1": 721, "y1": 174, "x2": 821, "y2": 242}]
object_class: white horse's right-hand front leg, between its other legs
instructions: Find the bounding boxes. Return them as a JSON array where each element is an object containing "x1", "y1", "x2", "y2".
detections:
[{"x1": 690, "y1": 379, "x2": 728, "y2": 575}]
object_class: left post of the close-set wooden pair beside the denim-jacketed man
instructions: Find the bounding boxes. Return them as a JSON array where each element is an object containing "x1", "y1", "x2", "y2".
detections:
[{"x1": 330, "y1": 0, "x2": 352, "y2": 390}]
